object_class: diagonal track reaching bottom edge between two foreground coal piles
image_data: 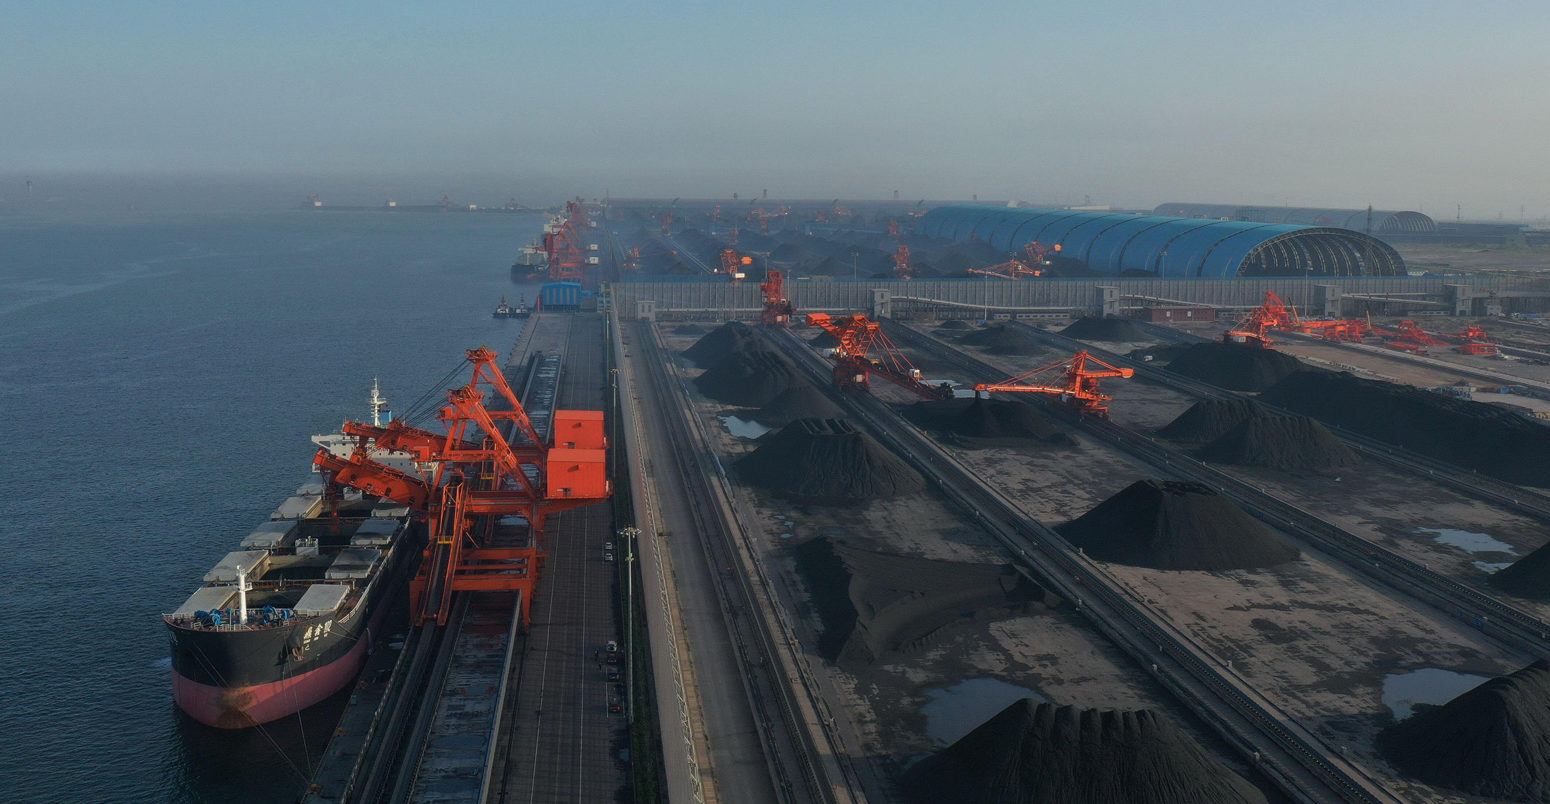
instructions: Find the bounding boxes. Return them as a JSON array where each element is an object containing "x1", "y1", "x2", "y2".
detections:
[{"x1": 777, "y1": 332, "x2": 1398, "y2": 802}]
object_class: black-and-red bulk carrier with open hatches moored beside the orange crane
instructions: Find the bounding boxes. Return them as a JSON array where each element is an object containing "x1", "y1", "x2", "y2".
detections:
[{"x1": 163, "y1": 383, "x2": 425, "y2": 728}]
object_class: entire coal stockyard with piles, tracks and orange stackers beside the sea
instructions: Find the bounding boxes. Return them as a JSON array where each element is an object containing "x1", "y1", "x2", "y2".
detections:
[{"x1": 244, "y1": 200, "x2": 1550, "y2": 804}]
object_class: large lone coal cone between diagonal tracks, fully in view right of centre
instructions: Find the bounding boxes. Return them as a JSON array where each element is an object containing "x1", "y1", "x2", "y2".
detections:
[{"x1": 1056, "y1": 480, "x2": 1300, "y2": 572}]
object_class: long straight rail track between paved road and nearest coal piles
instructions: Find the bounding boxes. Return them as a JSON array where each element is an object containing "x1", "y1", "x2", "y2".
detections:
[{"x1": 634, "y1": 317, "x2": 865, "y2": 802}]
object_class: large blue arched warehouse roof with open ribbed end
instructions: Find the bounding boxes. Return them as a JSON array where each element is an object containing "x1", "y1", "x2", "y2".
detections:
[{"x1": 918, "y1": 204, "x2": 1404, "y2": 279}]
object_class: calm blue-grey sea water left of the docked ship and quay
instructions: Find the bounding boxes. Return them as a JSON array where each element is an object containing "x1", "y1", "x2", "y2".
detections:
[{"x1": 0, "y1": 211, "x2": 541, "y2": 802}]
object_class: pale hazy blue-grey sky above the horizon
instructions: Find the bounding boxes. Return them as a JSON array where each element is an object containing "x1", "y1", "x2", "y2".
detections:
[{"x1": 0, "y1": 0, "x2": 1550, "y2": 220}]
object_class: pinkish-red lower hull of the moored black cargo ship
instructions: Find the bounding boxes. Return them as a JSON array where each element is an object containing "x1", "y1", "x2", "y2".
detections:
[{"x1": 172, "y1": 632, "x2": 370, "y2": 728}]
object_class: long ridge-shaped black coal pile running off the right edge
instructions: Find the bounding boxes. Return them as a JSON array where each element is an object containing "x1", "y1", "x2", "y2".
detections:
[{"x1": 1263, "y1": 372, "x2": 1550, "y2": 488}]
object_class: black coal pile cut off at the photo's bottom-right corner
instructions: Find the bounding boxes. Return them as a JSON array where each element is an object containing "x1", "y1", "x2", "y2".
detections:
[{"x1": 1378, "y1": 660, "x2": 1550, "y2": 802}]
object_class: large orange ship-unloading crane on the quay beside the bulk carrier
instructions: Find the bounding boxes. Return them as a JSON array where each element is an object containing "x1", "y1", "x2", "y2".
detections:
[{"x1": 313, "y1": 347, "x2": 612, "y2": 629}]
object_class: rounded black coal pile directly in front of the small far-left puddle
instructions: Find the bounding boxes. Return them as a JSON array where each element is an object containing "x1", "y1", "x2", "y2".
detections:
[{"x1": 738, "y1": 418, "x2": 925, "y2": 505}]
